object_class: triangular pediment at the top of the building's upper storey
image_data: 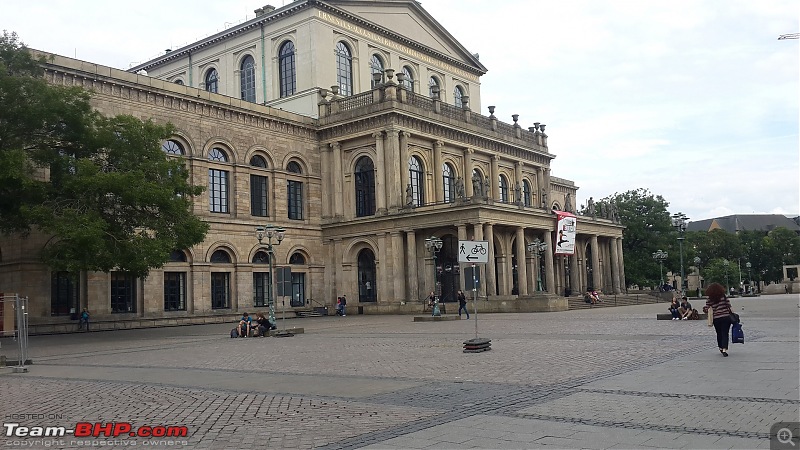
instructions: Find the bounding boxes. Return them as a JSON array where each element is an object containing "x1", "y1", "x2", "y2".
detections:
[{"x1": 320, "y1": 0, "x2": 486, "y2": 74}]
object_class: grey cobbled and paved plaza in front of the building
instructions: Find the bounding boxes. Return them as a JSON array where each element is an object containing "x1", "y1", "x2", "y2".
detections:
[{"x1": 0, "y1": 295, "x2": 800, "y2": 450}]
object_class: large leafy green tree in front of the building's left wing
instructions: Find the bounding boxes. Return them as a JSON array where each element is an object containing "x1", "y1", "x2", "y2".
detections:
[{"x1": 0, "y1": 32, "x2": 208, "y2": 276}]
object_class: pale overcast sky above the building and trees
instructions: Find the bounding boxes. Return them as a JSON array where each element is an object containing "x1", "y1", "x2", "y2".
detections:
[{"x1": 0, "y1": 0, "x2": 800, "y2": 220}]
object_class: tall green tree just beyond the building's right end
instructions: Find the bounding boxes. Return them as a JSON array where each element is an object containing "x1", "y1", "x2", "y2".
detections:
[{"x1": 598, "y1": 188, "x2": 679, "y2": 286}]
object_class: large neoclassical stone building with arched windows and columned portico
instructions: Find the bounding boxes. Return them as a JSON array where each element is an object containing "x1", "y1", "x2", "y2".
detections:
[{"x1": 0, "y1": 0, "x2": 625, "y2": 331}]
